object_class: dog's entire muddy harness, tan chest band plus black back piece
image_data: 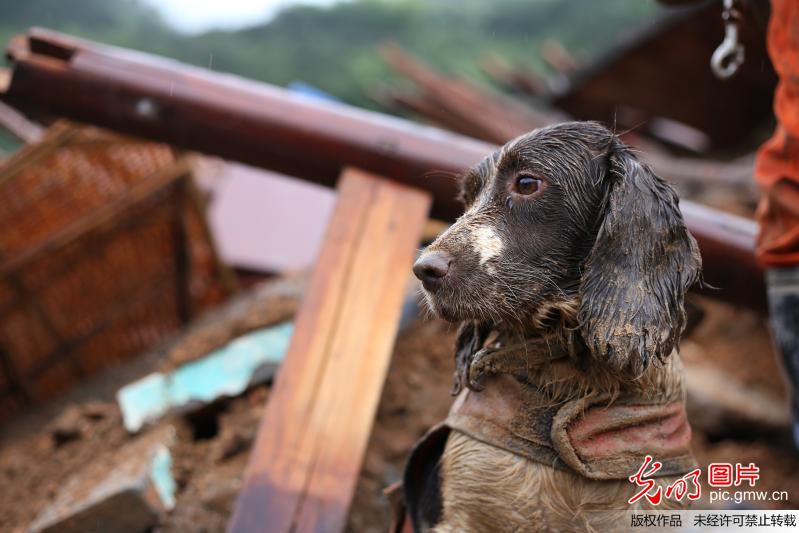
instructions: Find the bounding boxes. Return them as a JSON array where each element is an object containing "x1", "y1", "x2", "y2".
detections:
[{"x1": 396, "y1": 342, "x2": 697, "y2": 531}]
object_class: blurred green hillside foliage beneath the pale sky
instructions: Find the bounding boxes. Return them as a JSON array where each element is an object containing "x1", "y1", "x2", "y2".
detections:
[{"x1": 0, "y1": 0, "x2": 657, "y2": 107}]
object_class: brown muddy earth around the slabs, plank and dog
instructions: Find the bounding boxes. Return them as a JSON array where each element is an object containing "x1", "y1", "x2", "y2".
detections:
[{"x1": 0, "y1": 280, "x2": 799, "y2": 532}]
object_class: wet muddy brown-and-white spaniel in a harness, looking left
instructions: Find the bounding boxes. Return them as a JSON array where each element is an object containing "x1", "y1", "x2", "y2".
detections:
[{"x1": 404, "y1": 122, "x2": 701, "y2": 532}]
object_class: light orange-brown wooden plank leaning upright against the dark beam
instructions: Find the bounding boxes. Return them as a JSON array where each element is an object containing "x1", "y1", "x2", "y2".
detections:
[{"x1": 229, "y1": 170, "x2": 430, "y2": 533}]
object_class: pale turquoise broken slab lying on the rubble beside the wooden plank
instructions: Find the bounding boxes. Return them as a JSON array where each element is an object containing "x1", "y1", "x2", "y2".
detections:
[{"x1": 117, "y1": 322, "x2": 294, "y2": 433}]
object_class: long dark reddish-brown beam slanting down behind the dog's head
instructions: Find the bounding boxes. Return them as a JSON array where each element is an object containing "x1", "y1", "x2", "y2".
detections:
[{"x1": 0, "y1": 29, "x2": 765, "y2": 310}]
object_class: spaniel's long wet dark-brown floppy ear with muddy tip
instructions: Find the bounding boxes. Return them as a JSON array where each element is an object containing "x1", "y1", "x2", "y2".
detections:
[{"x1": 579, "y1": 141, "x2": 701, "y2": 375}]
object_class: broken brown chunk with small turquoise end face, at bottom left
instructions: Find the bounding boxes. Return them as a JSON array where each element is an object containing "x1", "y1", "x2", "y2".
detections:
[{"x1": 29, "y1": 426, "x2": 176, "y2": 533}]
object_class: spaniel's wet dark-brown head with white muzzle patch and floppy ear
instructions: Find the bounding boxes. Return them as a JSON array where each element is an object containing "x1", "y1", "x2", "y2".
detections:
[{"x1": 414, "y1": 122, "x2": 701, "y2": 372}]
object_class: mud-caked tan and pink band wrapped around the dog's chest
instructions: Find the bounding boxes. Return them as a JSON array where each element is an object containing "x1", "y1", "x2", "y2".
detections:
[{"x1": 443, "y1": 375, "x2": 695, "y2": 479}]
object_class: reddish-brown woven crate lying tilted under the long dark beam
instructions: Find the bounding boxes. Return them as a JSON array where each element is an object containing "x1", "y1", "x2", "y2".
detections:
[{"x1": 0, "y1": 123, "x2": 231, "y2": 419}]
